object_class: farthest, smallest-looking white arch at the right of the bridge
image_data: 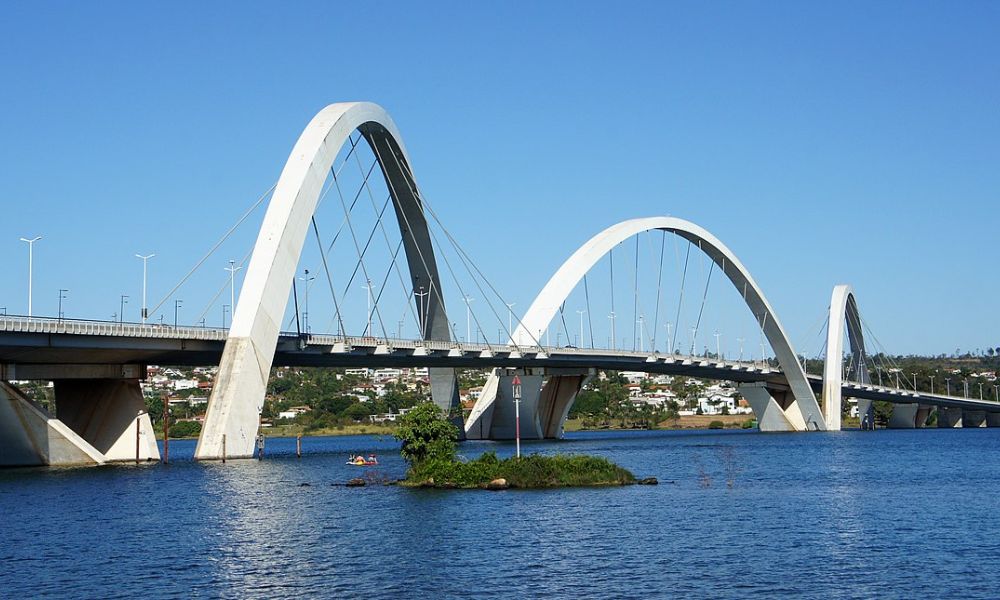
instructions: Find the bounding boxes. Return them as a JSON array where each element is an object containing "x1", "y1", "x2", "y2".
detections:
[{"x1": 823, "y1": 284, "x2": 870, "y2": 431}]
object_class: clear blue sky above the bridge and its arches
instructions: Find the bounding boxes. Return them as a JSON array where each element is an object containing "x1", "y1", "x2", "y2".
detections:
[{"x1": 0, "y1": 2, "x2": 1000, "y2": 353}]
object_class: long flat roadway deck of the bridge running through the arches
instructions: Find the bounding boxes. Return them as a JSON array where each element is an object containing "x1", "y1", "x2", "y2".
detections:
[{"x1": 0, "y1": 316, "x2": 1000, "y2": 413}]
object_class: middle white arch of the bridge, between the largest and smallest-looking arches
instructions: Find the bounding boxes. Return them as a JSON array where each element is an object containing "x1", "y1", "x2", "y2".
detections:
[{"x1": 512, "y1": 217, "x2": 826, "y2": 431}]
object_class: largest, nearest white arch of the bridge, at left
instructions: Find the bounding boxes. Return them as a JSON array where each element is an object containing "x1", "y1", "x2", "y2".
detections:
[{"x1": 195, "y1": 102, "x2": 457, "y2": 459}]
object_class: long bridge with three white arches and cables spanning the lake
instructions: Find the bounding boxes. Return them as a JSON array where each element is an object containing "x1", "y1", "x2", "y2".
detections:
[{"x1": 0, "y1": 103, "x2": 1000, "y2": 465}]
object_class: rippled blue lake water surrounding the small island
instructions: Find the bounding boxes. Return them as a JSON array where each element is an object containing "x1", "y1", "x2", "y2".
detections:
[{"x1": 0, "y1": 429, "x2": 1000, "y2": 599}]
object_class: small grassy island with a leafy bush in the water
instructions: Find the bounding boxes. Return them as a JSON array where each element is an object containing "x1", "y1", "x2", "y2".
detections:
[{"x1": 394, "y1": 402, "x2": 636, "y2": 490}]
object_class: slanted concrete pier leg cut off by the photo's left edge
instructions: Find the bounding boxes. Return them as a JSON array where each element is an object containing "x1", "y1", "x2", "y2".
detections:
[{"x1": 0, "y1": 381, "x2": 104, "y2": 467}]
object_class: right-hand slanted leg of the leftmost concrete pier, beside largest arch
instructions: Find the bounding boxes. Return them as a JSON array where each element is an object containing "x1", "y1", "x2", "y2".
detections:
[{"x1": 55, "y1": 379, "x2": 160, "y2": 461}]
